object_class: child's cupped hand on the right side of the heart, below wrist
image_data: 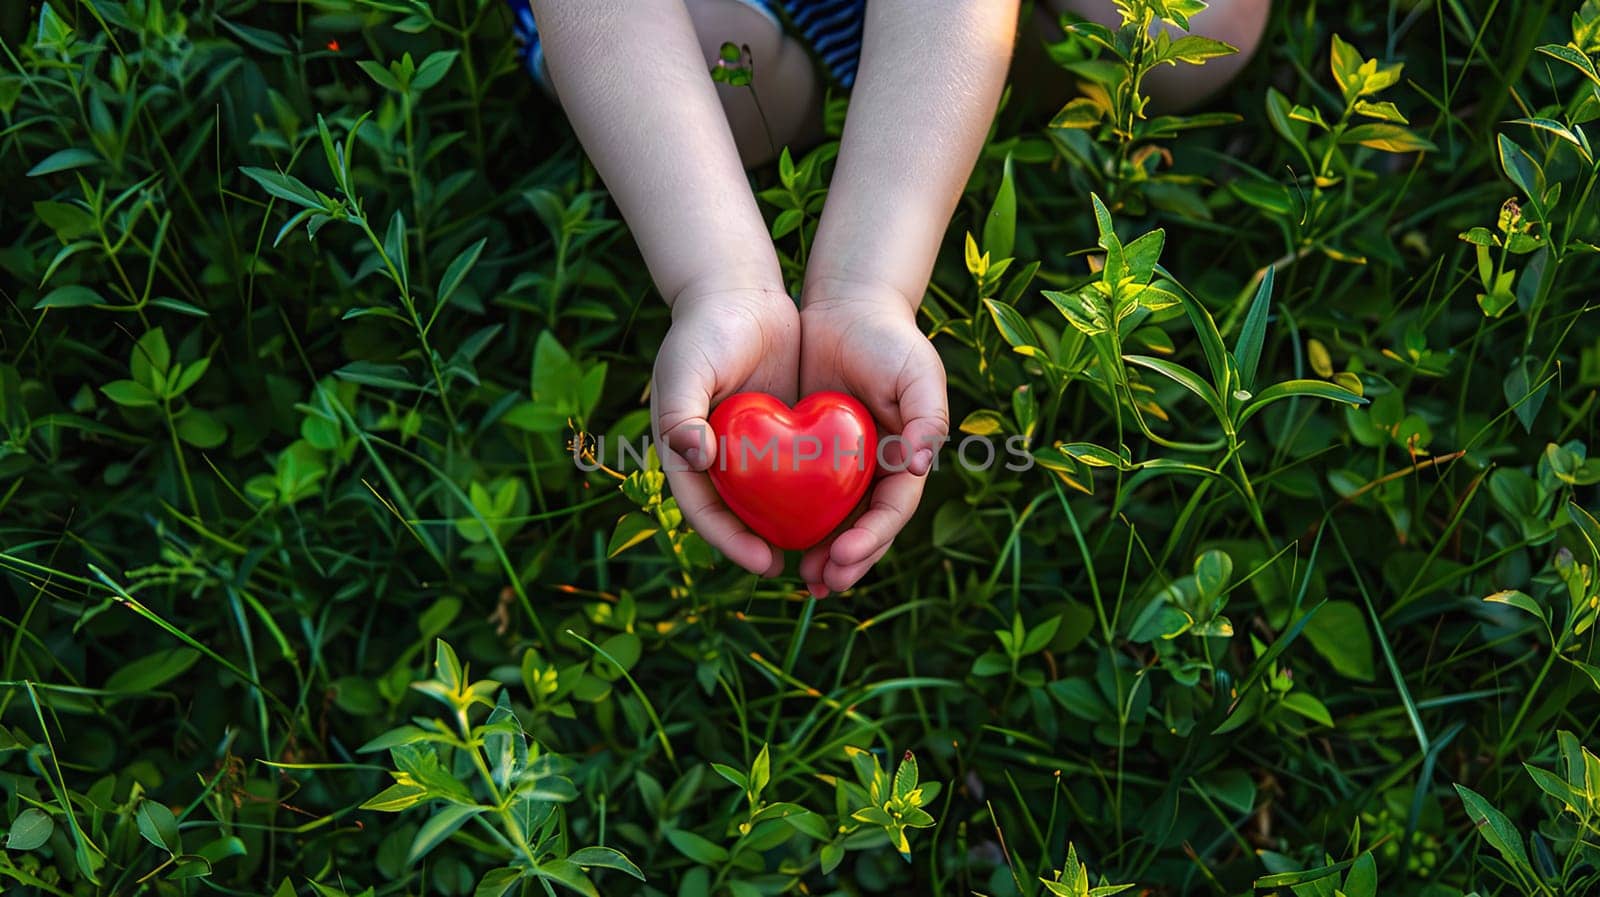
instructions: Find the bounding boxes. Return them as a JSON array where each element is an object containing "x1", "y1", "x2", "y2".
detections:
[{"x1": 800, "y1": 283, "x2": 950, "y2": 598}]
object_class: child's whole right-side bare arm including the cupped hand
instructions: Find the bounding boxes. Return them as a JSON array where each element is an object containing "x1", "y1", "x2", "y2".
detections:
[{"x1": 800, "y1": 0, "x2": 1018, "y2": 596}]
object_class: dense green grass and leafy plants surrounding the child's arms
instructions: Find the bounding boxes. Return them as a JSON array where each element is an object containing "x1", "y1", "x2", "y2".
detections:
[{"x1": 0, "y1": 0, "x2": 1600, "y2": 897}]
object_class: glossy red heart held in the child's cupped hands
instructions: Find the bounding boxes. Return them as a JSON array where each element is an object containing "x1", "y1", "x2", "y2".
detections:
[{"x1": 709, "y1": 392, "x2": 878, "y2": 550}]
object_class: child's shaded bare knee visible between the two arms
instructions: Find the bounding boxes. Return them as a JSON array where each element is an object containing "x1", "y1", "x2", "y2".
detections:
[{"x1": 688, "y1": 0, "x2": 821, "y2": 166}]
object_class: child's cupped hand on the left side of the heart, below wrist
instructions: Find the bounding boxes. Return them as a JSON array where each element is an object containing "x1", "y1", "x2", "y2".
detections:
[{"x1": 650, "y1": 289, "x2": 800, "y2": 576}]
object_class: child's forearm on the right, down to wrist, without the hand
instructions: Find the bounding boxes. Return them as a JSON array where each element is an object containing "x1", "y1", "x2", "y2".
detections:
[{"x1": 806, "y1": 0, "x2": 1018, "y2": 307}]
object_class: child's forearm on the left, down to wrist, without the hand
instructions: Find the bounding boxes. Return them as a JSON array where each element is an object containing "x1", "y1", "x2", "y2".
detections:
[{"x1": 533, "y1": 0, "x2": 782, "y2": 304}]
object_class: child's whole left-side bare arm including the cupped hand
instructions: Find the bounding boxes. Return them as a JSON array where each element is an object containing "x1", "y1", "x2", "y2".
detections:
[{"x1": 533, "y1": 0, "x2": 800, "y2": 576}]
